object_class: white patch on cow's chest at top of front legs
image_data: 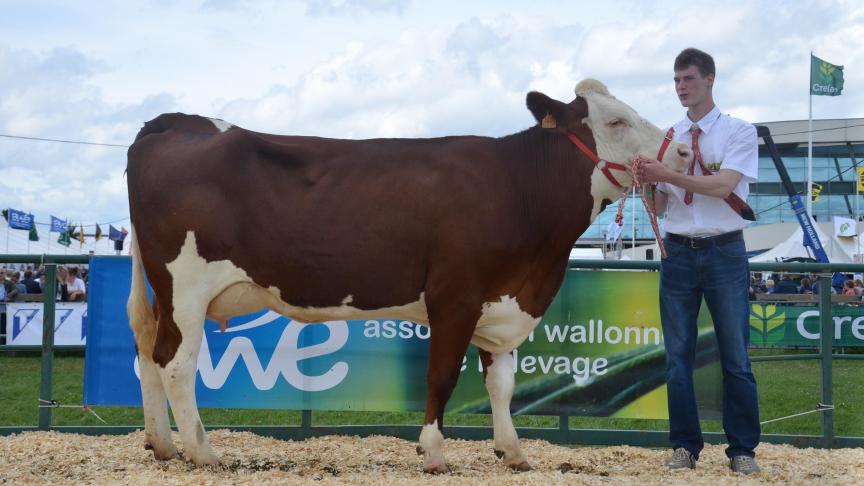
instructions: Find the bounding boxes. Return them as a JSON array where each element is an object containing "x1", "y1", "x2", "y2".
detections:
[{"x1": 471, "y1": 295, "x2": 540, "y2": 354}]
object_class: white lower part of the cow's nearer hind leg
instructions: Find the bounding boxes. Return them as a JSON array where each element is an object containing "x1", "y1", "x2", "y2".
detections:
[{"x1": 157, "y1": 299, "x2": 219, "y2": 466}]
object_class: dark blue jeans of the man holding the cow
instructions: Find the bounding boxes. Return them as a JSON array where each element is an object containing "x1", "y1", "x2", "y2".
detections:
[{"x1": 660, "y1": 238, "x2": 760, "y2": 458}]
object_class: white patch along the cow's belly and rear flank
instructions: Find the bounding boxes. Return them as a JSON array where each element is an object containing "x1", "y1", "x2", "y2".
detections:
[{"x1": 168, "y1": 231, "x2": 429, "y2": 324}]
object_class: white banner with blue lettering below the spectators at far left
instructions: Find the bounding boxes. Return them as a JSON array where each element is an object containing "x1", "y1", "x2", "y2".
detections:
[{"x1": 6, "y1": 302, "x2": 87, "y2": 346}]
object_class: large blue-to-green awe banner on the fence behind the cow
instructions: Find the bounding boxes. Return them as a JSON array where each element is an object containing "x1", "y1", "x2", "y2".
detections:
[{"x1": 84, "y1": 257, "x2": 721, "y2": 418}]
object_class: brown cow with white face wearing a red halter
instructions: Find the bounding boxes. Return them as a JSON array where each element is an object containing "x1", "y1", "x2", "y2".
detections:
[{"x1": 127, "y1": 79, "x2": 692, "y2": 473}]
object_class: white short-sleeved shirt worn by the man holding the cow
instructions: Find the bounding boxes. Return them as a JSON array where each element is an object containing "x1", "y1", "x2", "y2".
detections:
[{"x1": 657, "y1": 105, "x2": 759, "y2": 237}]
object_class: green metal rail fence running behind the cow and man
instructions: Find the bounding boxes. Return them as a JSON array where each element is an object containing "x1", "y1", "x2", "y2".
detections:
[{"x1": 0, "y1": 255, "x2": 864, "y2": 448}]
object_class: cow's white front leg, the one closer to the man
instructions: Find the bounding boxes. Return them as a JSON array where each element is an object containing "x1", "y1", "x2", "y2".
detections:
[{"x1": 480, "y1": 349, "x2": 531, "y2": 471}]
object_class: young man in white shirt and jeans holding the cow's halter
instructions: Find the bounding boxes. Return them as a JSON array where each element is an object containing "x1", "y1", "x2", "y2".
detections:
[{"x1": 637, "y1": 48, "x2": 760, "y2": 474}]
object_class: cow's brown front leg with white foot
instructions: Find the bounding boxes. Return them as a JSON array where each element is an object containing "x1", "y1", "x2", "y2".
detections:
[{"x1": 418, "y1": 306, "x2": 479, "y2": 474}]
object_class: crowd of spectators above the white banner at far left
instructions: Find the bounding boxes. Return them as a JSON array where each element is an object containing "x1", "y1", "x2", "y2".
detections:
[{"x1": 0, "y1": 264, "x2": 88, "y2": 302}]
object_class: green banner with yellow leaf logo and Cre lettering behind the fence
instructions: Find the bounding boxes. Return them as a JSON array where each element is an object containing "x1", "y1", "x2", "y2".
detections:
[{"x1": 750, "y1": 302, "x2": 864, "y2": 347}]
